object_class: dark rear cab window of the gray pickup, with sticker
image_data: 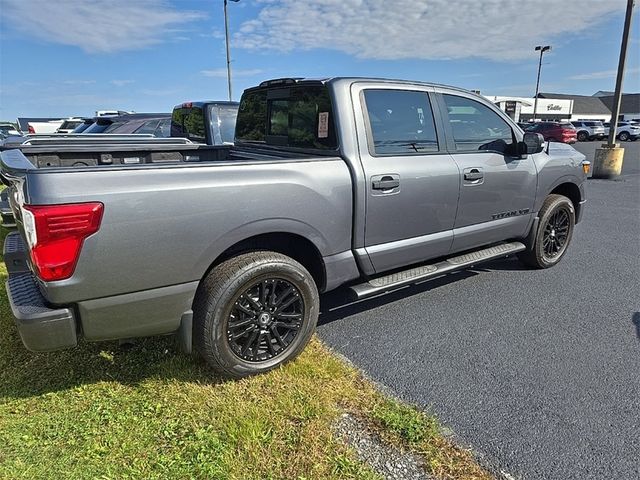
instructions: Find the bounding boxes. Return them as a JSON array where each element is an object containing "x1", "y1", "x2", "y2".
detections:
[{"x1": 236, "y1": 85, "x2": 338, "y2": 150}]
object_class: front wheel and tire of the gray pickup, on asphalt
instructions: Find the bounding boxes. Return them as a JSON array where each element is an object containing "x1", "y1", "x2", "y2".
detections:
[{"x1": 518, "y1": 194, "x2": 576, "y2": 268}]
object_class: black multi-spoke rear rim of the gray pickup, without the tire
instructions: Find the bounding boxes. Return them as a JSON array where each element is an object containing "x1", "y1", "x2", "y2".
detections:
[{"x1": 227, "y1": 278, "x2": 304, "y2": 362}]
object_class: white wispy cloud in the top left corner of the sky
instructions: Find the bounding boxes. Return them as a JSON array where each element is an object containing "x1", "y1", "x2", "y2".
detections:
[{"x1": 2, "y1": 0, "x2": 204, "y2": 53}]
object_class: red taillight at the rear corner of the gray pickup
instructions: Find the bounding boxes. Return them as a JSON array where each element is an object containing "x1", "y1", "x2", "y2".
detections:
[{"x1": 23, "y1": 202, "x2": 104, "y2": 282}]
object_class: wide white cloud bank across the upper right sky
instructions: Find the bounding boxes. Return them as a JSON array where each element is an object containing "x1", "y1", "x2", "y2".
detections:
[{"x1": 234, "y1": 0, "x2": 626, "y2": 60}]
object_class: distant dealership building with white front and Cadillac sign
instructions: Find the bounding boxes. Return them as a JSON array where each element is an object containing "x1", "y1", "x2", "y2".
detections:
[{"x1": 484, "y1": 92, "x2": 640, "y2": 122}]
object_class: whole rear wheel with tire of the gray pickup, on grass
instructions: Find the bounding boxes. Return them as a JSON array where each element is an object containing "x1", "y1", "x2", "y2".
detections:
[{"x1": 193, "y1": 251, "x2": 320, "y2": 378}]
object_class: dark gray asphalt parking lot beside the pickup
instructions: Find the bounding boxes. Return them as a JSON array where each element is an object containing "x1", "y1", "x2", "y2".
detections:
[{"x1": 319, "y1": 141, "x2": 640, "y2": 479}]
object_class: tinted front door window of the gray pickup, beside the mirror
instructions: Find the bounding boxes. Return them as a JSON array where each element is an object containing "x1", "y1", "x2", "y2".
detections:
[{"x1": 443, "y1": 95, "x2": 513, "y2": 153}]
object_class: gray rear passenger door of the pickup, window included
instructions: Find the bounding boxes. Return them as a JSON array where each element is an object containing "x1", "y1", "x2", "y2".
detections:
[{"x1": 351, "y1": 82, "x2": 459, "y2": 272}]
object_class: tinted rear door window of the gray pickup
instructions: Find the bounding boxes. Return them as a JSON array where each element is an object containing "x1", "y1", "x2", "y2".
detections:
[{"x1": 364, "y1": 89, "x2": 438, "y2": 155}]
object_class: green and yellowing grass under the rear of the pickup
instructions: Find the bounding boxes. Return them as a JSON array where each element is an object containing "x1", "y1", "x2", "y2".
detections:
[{"x1": 0, "y1": 226, "x2": 490, "y2": 480}]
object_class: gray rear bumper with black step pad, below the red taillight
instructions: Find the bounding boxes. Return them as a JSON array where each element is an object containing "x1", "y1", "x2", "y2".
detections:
[{"x1": 3, "y1": 232, "x2": 78, "y2": 352}]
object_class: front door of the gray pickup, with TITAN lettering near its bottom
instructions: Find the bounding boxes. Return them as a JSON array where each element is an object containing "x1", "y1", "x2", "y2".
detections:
[{"x1": 438, "y1": 89, "x2": 537, "y2": 251}]
